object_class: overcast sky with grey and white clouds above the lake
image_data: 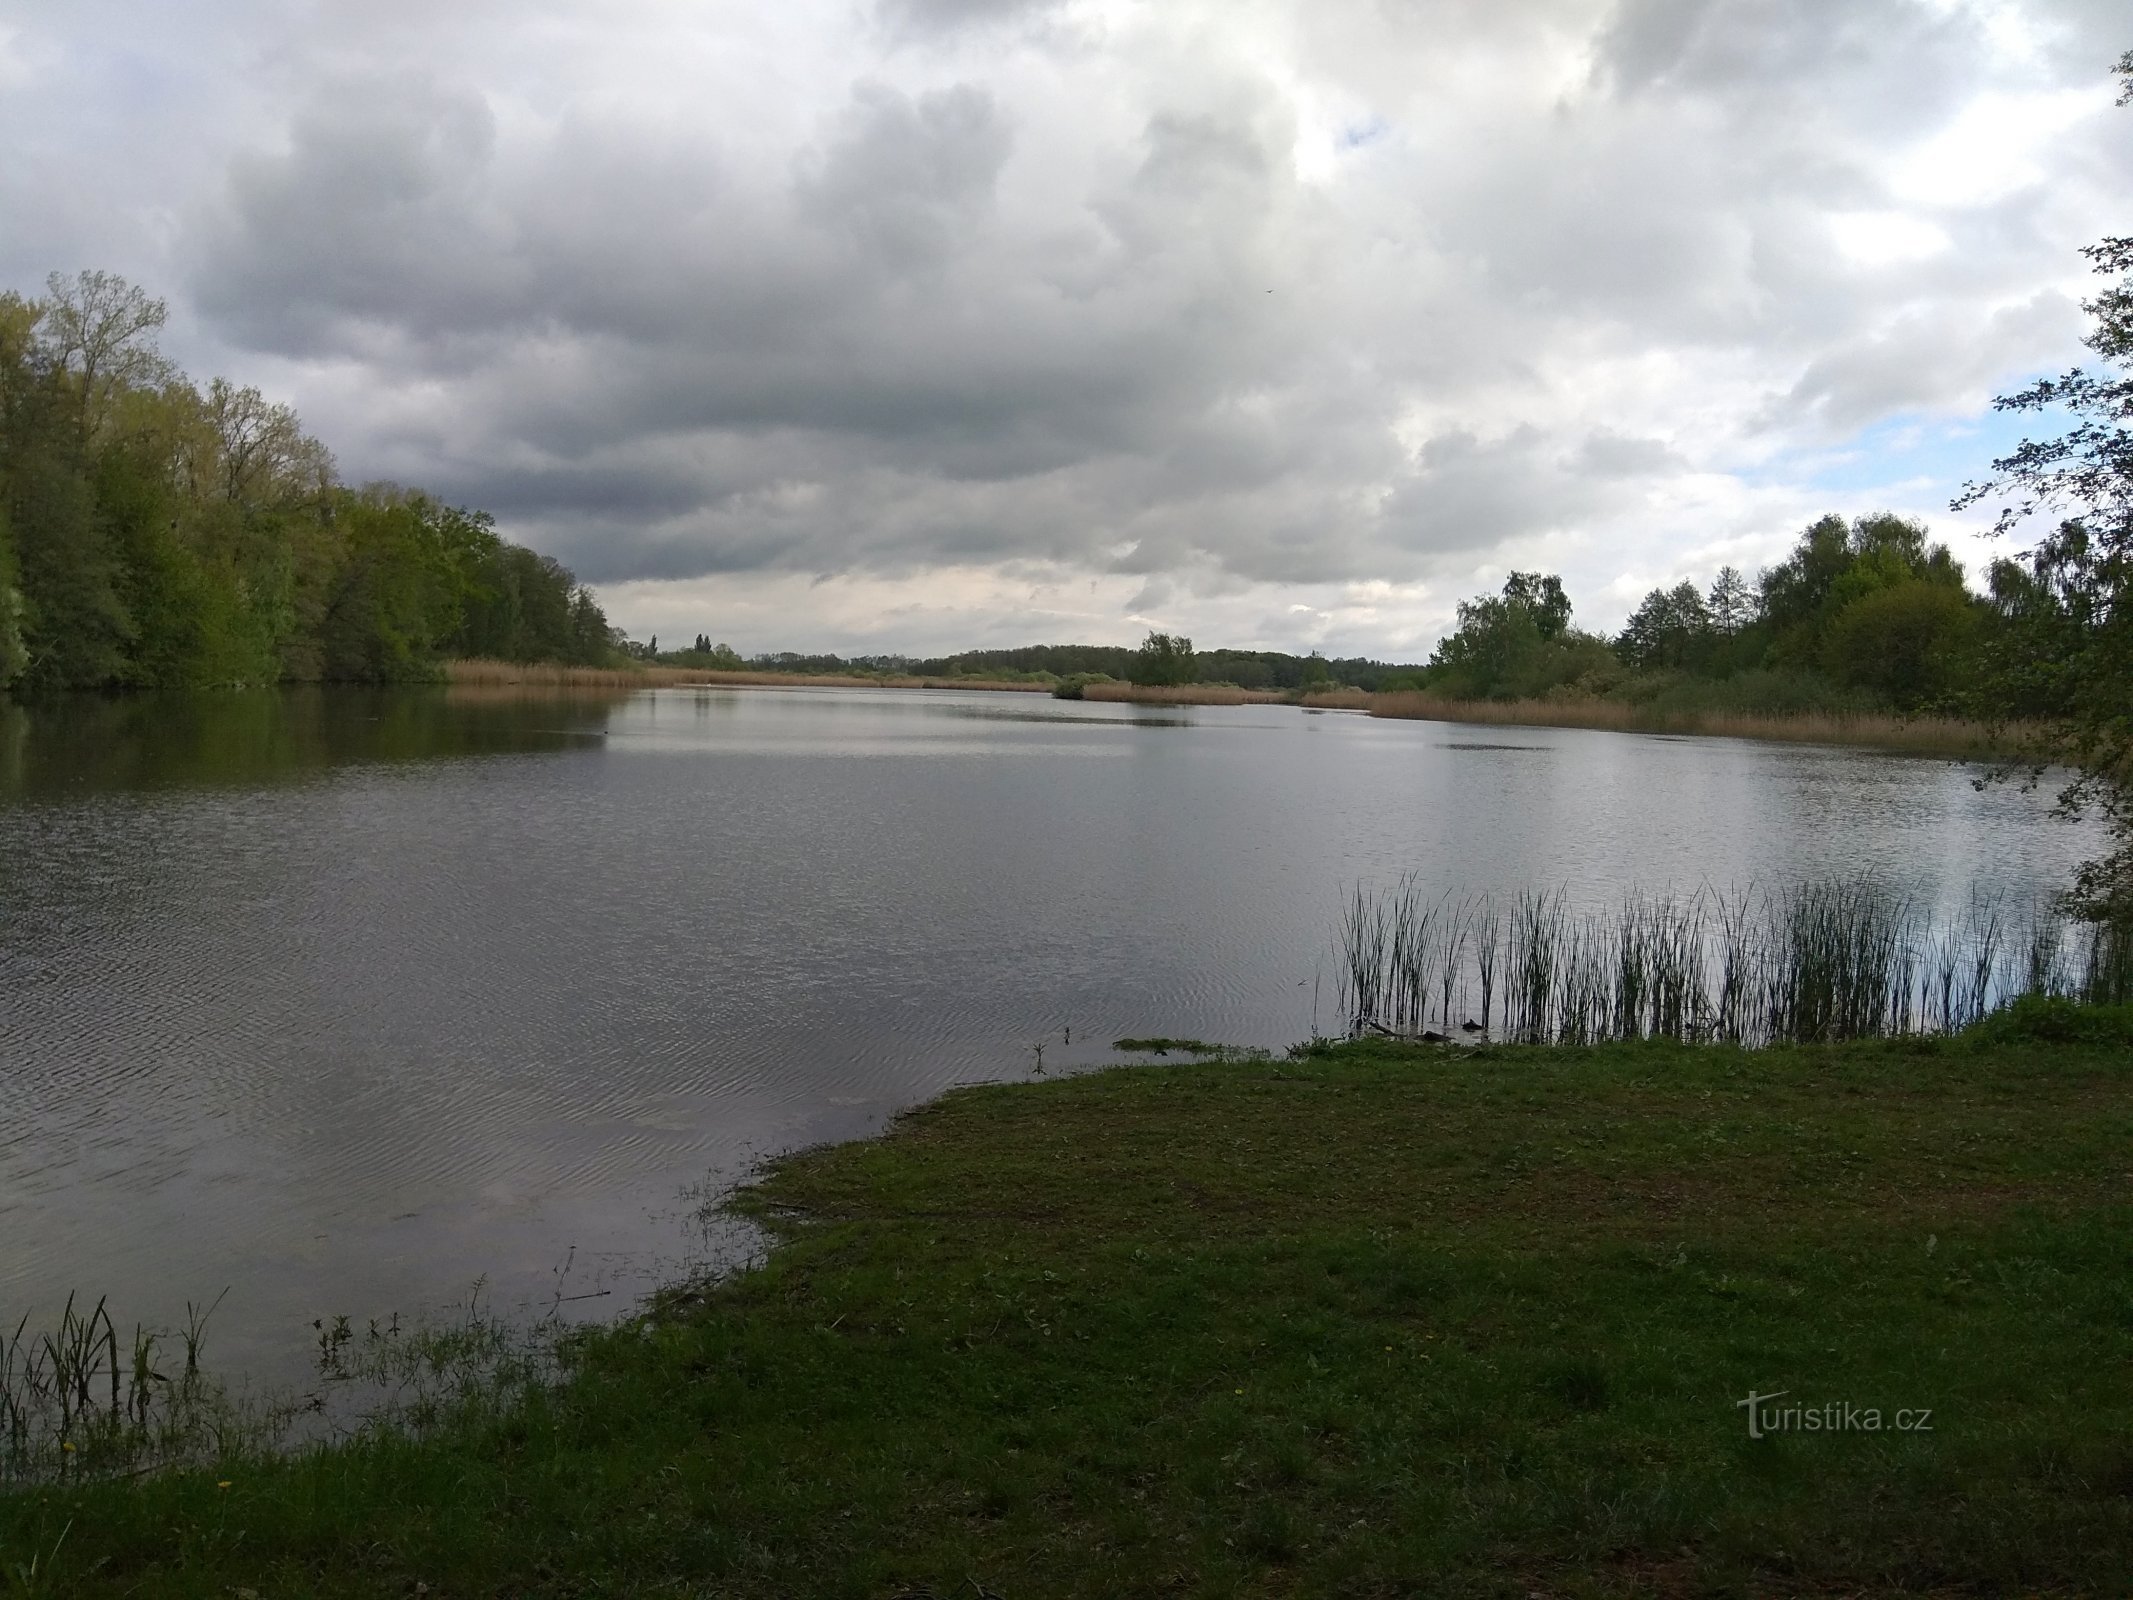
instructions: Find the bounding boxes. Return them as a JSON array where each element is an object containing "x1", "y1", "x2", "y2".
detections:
[{"x1": 0, "y1": 0, "x2": 2133, "y2": 657}]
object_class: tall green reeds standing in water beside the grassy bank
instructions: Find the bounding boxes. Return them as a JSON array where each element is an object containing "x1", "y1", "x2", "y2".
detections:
[{"x1": 1335, "y1": 873, "x2": 2133, "y2": 1045}]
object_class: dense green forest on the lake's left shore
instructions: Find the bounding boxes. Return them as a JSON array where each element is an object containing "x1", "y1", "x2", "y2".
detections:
[{"x1": 0, "y1": 271, "x2": 616, "y2": 698}]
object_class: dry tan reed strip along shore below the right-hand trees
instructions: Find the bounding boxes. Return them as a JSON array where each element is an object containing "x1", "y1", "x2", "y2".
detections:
[{"x1": 1369, "y1": 689, "x2": 2033, "y2": 759}]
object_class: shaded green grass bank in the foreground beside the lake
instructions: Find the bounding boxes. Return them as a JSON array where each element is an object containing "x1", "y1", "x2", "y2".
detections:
[{"x1": 0, "y1": 1005, "x2": 2133, "y2": 1600}]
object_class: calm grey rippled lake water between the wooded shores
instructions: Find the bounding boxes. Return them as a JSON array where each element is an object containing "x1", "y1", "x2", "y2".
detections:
[{"x1": 0, "y1": 689, "x2": 2092, "y2": 1376}]
